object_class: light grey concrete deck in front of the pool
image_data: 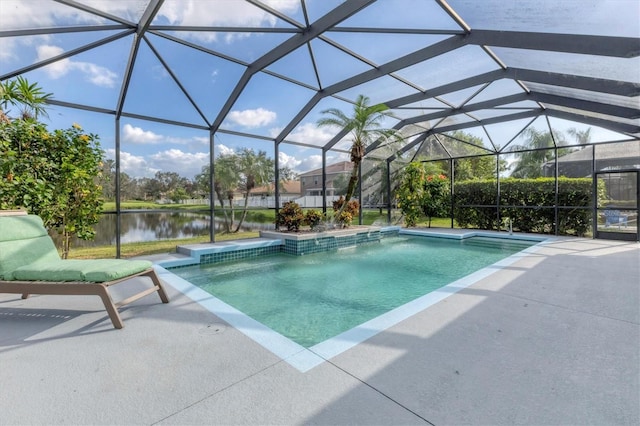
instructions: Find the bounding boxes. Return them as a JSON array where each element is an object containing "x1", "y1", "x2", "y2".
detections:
[{"x1": 0, "y1": 238, "x2": 640, "y2": 425}]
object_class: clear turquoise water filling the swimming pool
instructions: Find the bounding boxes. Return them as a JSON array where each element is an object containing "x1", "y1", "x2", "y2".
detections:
[{"x1": 172, "y1": 236, "x2": 536, "y2": 348}]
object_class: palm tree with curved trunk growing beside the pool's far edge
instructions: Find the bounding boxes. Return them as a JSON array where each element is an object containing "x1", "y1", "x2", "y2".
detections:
[{"x1": 318, "y1": 95, "x2": 400, "y2": 218}]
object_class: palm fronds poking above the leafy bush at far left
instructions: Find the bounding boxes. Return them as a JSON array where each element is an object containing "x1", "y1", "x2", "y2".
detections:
[{"x1": 0, "y1": 77, "x2": 53, "y2": 120}]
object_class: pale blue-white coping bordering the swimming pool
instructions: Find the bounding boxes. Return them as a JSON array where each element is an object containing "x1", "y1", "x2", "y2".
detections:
[{"x1": 155, "y1": 227, "x2": 556, "y2": 373}]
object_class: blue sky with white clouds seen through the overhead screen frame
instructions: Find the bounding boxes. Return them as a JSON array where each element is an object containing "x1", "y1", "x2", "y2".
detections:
[{"x1": 0, "y1": 0, "x2": 640, "y2": 178}]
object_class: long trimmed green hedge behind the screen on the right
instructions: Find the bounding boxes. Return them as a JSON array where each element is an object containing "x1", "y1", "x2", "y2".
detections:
[{"x1": 453, "y1": 177, "x2": 604, "y2": 236}]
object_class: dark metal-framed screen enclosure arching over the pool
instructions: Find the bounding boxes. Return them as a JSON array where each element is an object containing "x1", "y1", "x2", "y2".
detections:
[{"x1": 0, "y1": 0, "x2": 640, "y2": 256}]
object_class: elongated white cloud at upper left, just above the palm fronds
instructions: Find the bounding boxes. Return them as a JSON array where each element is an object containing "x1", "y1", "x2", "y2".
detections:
[{"x1": 36, "y1": 44, "x2": 118, "y2": 87}]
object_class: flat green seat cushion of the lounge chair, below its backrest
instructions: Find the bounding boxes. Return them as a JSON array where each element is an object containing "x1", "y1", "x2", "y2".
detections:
[{"x1": 13, "y1": 259, "x2": 152, "y2": 282}]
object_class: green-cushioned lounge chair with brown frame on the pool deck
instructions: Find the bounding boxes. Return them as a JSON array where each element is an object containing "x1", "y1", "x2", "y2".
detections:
[{"x1": 0, "y1": 211, "x2": 169, "y2": 328}]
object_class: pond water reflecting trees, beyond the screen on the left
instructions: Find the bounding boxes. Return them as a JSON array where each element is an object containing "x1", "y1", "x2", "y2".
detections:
[{"x1": 54, "y1": 212, "x2": 274, "y2": 247}]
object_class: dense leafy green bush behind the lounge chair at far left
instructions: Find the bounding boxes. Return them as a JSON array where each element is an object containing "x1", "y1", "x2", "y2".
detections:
[{"x1": 0, "y1": 119, "x2": 103, "y2": 258}]
